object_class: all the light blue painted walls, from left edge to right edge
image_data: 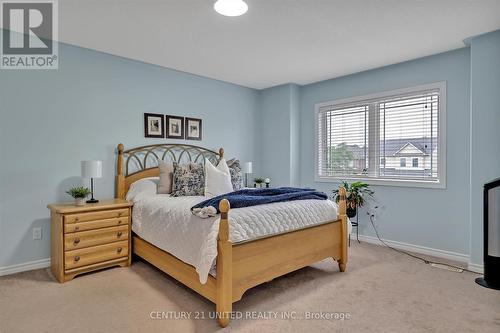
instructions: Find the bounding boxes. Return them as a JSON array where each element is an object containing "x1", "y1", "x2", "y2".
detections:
[{"x1": 0, "y1": 32, "x2": 500, "y2": 267}]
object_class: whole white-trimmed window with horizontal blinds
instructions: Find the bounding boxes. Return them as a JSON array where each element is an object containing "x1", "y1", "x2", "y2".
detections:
[{"x1": 315, "y1": 82, "x2": 446, "y2": 188}]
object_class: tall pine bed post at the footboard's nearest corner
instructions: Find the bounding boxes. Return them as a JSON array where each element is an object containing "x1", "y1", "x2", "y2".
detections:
[{"x1": 216, "y1": 197, "x2": 233, "y2": 327}]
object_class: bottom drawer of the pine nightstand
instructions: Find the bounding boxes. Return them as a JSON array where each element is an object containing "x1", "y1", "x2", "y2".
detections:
[{"x1": 64, "y1": 241, "x2": 128, "y2": 270}]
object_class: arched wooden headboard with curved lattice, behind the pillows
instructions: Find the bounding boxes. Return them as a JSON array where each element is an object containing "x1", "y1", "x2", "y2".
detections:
[{"x1": 116, "y1": 143, "x2": 224, "y2": 199}]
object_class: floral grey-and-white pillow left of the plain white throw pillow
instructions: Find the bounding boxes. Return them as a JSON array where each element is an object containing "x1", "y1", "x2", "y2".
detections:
[{"x1": 172, "y1": 162, "x2": 205, "y2": 197}]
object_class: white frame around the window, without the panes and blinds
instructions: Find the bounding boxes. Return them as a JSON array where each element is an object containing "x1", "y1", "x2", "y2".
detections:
[{"x1": 314, "y1": 81, "x2": 446, "y2": 189}]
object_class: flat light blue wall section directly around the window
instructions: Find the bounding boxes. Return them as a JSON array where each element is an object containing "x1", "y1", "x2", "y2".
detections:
[{"x1": 300, "y1": 48, "x2": 470, "y2": 254}]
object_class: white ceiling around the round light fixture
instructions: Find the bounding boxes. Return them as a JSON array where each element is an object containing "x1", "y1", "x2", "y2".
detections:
[{"x1": 59, "y1": 0, "x2": 500, "y2": 89}]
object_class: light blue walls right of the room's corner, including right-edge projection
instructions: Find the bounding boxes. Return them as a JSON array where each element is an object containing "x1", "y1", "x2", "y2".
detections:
[{"x1": 260, "y1": 31, "x2": 500, "y2": 264}]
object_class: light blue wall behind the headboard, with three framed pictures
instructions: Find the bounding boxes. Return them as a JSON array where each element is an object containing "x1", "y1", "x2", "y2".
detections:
[{"x1": 0, "y1": 40, "x2": 260, "y2": 267}]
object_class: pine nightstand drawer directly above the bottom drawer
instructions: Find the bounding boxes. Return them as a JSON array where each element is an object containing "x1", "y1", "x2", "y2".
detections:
[{"x1": 64, "y1": 225, "x2": 128, "y2": 251}]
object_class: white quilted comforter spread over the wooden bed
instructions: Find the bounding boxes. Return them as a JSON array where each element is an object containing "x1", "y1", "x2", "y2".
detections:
[{"x1": 127, "y1": 178, "x2": 350, "y2": 284}]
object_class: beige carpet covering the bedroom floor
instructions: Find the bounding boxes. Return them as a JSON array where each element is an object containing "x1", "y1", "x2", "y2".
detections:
[{"x1": 0, "y1": 243, "x2": 500, "y2": 333}]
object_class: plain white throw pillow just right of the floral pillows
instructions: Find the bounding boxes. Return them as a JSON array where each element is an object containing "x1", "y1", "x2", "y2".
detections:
[{"x1": 205, "y1": 159, "x2": 233, "y2": 198}]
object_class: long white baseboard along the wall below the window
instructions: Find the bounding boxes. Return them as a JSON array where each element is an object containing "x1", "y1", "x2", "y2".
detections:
[{"x1": 351, "y1": 234, "x2": 470, "y2": 263}]
